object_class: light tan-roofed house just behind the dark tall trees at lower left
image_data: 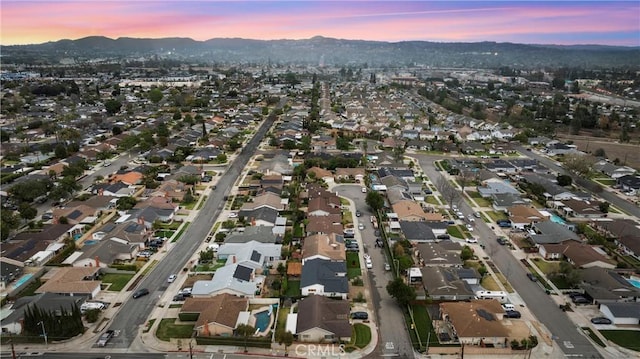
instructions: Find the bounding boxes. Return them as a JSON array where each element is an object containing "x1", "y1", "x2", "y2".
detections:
[{"x1": 35, "y1": 267, "x2": 101, "y2": 298}]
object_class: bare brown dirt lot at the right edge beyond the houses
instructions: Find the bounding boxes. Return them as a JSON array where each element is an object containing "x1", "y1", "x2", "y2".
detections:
[{"x1": 558, "y1": 134, "x2": 640, "y2": 168}]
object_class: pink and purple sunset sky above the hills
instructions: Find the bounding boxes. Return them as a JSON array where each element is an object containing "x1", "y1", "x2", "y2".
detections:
[{"x1": 0, "y1": 0, "x2": 640, "y2": 46}]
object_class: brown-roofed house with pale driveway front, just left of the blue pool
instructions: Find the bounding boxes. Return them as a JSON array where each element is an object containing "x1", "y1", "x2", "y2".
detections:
[{"x1": 180, "y1": 293, "x2": 249, "y2": 337}]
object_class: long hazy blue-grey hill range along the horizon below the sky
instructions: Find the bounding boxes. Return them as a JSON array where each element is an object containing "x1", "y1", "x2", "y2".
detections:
[{"x1": 0, "y1": 36, "x2": 640, "y2": 69}]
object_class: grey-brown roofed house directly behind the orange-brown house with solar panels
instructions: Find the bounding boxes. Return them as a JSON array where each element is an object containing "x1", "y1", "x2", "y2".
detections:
[{"x1": 420, "y1": 266, "x2": 475, "y2": 300}]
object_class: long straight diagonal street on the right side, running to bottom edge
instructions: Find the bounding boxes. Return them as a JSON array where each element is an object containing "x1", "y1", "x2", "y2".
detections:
[{"x1": 411, "y1": 154, "x2": 602, "y2": 358}]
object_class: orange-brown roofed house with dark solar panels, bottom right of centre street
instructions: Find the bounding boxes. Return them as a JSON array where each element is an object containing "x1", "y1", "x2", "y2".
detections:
[{"x1": 440, "y1": 299, "x2": 509, "y2": 348}]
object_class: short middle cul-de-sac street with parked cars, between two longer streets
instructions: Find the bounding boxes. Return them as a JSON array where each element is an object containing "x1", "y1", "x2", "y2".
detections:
[{"x1": 331, "y1": 185, "x2": 414, "y2": 358}]
